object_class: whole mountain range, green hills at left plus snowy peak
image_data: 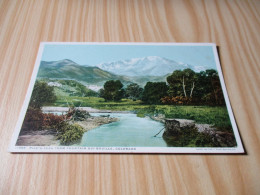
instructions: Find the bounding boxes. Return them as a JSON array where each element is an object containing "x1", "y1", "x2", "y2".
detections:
[{"x1": 37, "y1": 56, "x2": 211, "y2": 88}]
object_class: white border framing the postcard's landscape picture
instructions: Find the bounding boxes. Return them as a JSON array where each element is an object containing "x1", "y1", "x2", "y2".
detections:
[{"x1": 9, "y1": 42, "x2": 244, "y2": 154}]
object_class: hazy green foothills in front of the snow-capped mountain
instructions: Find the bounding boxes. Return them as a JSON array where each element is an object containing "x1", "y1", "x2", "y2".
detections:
[{"x1": 37, "y1": 59, "x2": 167, "y2": 87}]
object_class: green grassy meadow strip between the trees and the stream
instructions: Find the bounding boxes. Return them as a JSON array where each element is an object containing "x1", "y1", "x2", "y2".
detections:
[{"x1": 50, "y1": 96, "x2": 232, "y2": 131}]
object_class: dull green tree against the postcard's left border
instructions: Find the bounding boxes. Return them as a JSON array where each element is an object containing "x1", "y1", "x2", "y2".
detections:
[{"x1": 29, "y1": 81, "x2": 56, "y2": 109}]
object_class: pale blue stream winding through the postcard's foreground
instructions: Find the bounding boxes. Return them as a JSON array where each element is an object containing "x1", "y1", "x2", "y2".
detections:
[{"x1": 80, "y1": 113, "x2": 167, "y2": 147}]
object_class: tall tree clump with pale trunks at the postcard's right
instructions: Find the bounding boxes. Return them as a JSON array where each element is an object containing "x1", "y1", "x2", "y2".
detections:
[{"x1": 167, "y1": 69, "x2": 225, "y2": 105}]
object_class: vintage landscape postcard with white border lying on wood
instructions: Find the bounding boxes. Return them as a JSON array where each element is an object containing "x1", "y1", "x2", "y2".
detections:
[{"x1": 10, "y1": 42, "x2": 244, "y2": 153}]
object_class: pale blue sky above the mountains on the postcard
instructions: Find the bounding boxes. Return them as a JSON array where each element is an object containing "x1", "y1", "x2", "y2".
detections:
[{"x1": 42, "y1": 44, "x2": 216, "y2": 69}]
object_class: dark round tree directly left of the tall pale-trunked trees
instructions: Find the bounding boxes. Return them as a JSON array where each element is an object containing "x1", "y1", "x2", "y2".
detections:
[{"x1": 142, "y1": 82, "x2": 169, "y2": 104}]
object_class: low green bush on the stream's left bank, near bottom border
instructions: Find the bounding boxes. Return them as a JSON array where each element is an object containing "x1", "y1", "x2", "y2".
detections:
[{"x1": 58, "y1": 122, "x2": 84, "y2": 145}]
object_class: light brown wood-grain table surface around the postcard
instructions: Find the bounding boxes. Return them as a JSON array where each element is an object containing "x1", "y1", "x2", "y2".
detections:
[{"x1": 0, "y1": 0, "x2": 260, "y2": 195}]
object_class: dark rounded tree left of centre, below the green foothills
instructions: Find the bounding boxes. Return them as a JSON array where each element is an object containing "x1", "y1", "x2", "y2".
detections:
[{"x1": 100, "y1": 80, "x2": 124, "y2": 101}]
